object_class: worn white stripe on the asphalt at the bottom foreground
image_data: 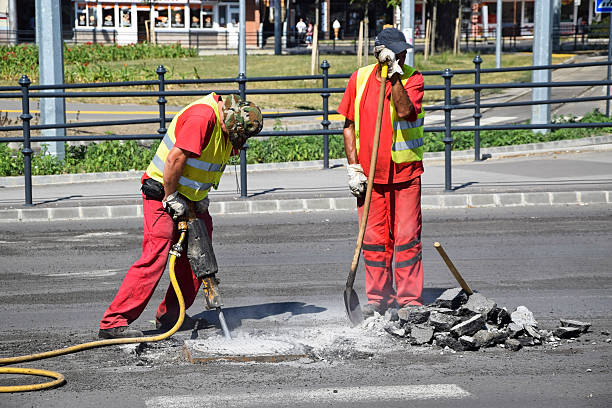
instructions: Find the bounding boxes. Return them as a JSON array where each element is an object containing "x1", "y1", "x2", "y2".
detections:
[{"x1": 146, "y1": 384, "x2": 471, "y2": 408}]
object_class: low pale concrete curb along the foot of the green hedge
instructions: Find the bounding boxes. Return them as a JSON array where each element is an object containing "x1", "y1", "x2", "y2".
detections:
[{"x1": 0, "y1": 135, "x2": 612, "y2": 187}]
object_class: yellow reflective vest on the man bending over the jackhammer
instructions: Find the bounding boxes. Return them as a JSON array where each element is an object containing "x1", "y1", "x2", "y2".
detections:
[{"x1": 147, "y1": 92, "x2": 232, "y2": 201}]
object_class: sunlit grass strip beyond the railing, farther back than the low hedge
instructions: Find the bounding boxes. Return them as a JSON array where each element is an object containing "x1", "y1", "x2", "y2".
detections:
[{"x1": 0, "y1": 44, "x2": 566, "y2": 110}]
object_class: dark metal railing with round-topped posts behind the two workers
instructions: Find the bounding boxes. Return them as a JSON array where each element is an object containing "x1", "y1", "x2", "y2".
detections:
[{"x1": 0, "y1": 55, "x2": 612, "y2": 206}]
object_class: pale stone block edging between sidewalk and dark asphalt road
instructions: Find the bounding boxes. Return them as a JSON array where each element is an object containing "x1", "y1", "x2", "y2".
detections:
[{"x1": 0, "y1": 191, "x2": 612, "y2": 223}]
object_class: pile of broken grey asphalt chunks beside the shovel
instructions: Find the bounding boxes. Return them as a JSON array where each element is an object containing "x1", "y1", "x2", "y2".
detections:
[{"x1": 362, "y1": 288, "x2": 612, "y2": 351}]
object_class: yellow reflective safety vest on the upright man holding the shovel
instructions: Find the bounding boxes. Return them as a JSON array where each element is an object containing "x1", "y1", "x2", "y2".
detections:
[{"x1": 355, "y1": 64, "x2": 425, "y2": 163}]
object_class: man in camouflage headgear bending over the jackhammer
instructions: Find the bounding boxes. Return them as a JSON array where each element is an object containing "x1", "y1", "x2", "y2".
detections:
[{"x1": 99, "y1": 93, "x2": 263, "y2": 339}]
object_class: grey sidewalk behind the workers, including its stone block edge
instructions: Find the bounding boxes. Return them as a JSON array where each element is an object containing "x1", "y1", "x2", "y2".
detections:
[{"x1": 0, "y1": 135, "x2": 612, "y2": 222}]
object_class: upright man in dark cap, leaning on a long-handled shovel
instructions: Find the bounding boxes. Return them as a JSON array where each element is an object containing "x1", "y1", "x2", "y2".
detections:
[{"x1": 338, "y1": 28, "x2": 425, "y2": 317}]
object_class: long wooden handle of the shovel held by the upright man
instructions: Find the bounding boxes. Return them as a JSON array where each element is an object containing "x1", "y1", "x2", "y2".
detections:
[{"x1": 346, "y1": 64, "x2": 388, "y2": 289}]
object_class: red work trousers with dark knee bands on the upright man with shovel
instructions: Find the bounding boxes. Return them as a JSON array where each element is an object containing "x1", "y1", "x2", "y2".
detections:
[{"x1": 357, "y1": 177, "x2": 423, "y2": 306}]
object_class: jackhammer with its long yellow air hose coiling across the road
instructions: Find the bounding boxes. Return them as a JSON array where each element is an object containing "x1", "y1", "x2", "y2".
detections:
[{"x1": 0, "y1": 203, "x2": 231, "y2": 393}]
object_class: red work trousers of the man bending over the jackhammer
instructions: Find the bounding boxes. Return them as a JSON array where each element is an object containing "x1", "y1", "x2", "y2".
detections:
[{"x1": 100, "y1": 195, "x2": 212, "y2": 329}]
